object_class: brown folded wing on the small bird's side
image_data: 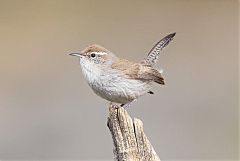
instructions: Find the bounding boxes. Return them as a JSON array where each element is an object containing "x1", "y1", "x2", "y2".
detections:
[{"x1": 112, "y1": 59, "x2": 164, "y2": 84}]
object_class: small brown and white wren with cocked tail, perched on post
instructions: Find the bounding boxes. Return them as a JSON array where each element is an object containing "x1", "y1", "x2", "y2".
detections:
[{"x1": 70, "y1": 33, "x2": 175, "y2": 105}]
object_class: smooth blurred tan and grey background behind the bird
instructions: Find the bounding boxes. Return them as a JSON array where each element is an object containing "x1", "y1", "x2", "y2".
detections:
[{"x1": 0, "y1": 0, "x2": 239, "y2": 161}]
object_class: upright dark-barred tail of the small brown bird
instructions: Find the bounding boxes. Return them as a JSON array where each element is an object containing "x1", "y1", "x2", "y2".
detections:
[{"x1": 141, "y1": 32, "x2": 176, "y2": 66}]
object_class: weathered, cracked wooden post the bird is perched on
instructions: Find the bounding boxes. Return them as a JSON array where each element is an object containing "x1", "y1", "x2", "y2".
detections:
[{"x1": 107, "y1": 105, "x2": 160, "y2": 161}]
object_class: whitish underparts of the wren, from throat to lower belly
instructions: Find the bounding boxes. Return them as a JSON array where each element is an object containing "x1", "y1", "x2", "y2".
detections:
[{"x1": 80, "y1": 59, "x2": 151, "y2": 104}]
